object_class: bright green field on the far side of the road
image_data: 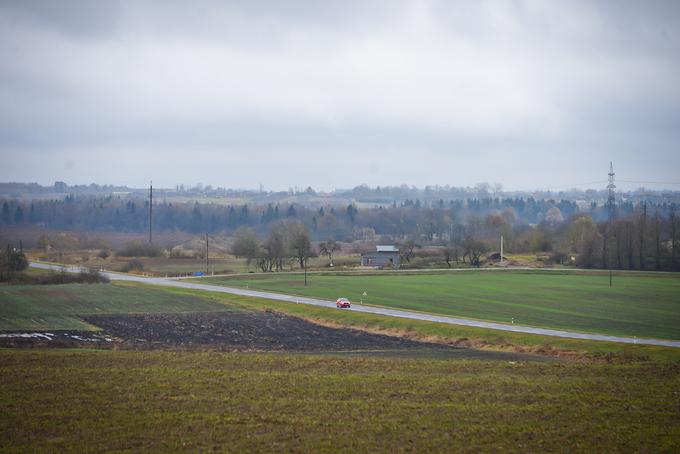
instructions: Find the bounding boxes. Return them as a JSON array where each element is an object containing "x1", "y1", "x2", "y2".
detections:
[{"x1": 205, "y1": 271, "x2": 680, "y2": 339}]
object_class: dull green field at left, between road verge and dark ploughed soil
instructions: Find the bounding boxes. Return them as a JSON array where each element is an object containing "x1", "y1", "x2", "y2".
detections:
[{"x1": 0, "y1": 284, "x2": 228, "y2": 331}]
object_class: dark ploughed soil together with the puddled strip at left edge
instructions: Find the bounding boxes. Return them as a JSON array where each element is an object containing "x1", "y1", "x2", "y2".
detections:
[{"x1": 0, "y1": 311, "x2": 541, "y2": 361}]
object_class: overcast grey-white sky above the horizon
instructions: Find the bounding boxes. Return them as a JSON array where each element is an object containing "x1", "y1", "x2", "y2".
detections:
[{"x1": 0, "y1": 0, "x2": 680, "y2": 190}]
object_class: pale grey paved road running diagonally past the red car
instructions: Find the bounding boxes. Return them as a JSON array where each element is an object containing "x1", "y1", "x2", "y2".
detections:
[{"x1": 30, "y1": 262, "x2": 680, "y2": 348}]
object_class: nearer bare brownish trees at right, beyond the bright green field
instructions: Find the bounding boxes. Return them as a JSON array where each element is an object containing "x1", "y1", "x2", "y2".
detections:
[{"x1": 432, "y1": 203, "x2": 680, "y2": 270}]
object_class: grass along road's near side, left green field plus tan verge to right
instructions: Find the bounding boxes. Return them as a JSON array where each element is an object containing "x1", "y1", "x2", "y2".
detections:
[{"x1": 5, "y1": 283, "x2": 680, "y2": 362}]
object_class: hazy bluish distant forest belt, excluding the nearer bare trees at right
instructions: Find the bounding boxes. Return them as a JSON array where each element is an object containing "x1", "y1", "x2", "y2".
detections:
[{"x1": 0, "y1": 194, "x2": 584, "y2": 239}]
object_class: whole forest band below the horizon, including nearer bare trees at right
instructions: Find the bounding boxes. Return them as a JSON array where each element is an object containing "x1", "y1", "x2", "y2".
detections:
[{"x1": 0, "y1": 190, "x2": 678, "y2": 270}]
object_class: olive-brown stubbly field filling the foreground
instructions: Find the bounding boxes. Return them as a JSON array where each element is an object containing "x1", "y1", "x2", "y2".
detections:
[{"x1": 0, "y1": 350, "x2": 680, "y2": 452}]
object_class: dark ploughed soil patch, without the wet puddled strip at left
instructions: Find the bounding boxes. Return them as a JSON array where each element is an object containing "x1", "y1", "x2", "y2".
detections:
[{"x1": 71, "y1": 311, "x2": 536, "y2": 360}]
